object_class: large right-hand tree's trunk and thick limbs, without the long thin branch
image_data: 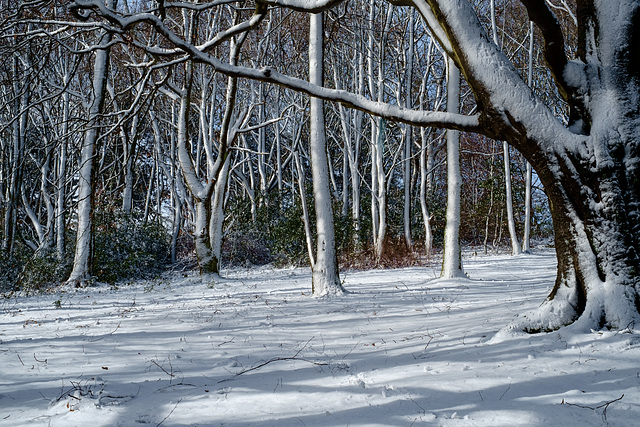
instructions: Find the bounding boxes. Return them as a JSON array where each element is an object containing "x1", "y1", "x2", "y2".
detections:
[{"x1": 431, "y1": 0, "x2": 640, "y2": 332}]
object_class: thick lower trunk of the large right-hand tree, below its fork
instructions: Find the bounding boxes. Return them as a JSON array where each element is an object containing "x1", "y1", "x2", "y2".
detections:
[{"x1": 515, "y1": 154, "x2": 640, "y2": 332}]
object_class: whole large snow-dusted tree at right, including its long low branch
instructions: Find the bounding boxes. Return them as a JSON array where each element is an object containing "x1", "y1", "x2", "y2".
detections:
[{"x1": 67, "y1": 0, "x2": 640, "y2": 332}]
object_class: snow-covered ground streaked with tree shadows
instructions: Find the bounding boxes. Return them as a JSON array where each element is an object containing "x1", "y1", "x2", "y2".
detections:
[{"x1": 0, "y1": 252, "x2": 640, "y2": 427}]
